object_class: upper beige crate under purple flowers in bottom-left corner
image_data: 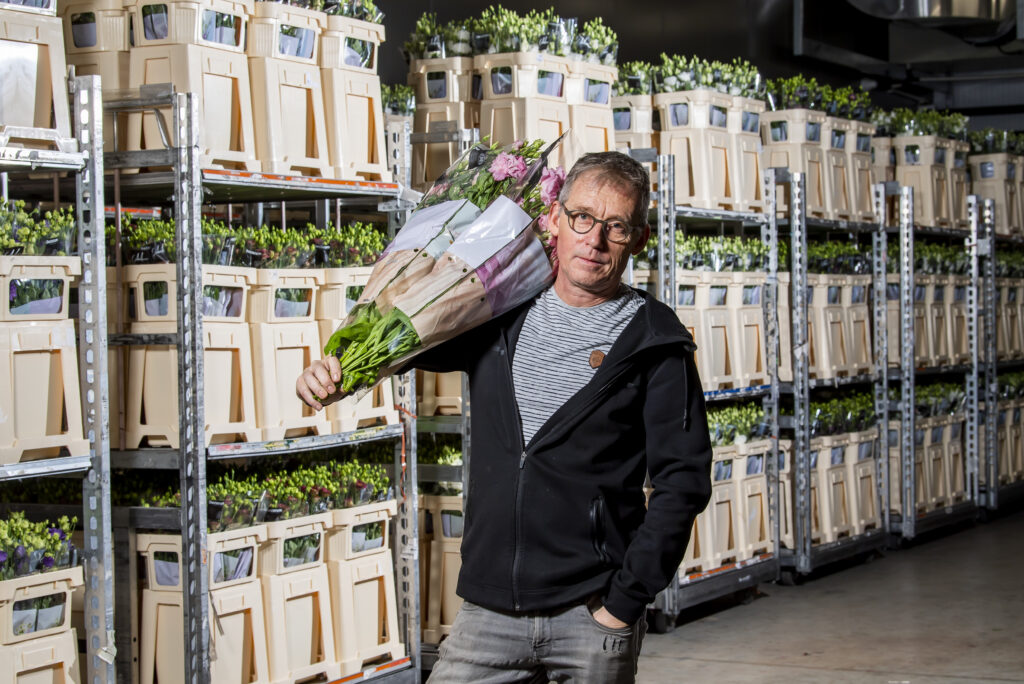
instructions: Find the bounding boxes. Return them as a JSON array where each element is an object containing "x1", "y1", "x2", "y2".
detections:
[{"x1": 0, "y1": 566, "x2": 85, "y2": 643}]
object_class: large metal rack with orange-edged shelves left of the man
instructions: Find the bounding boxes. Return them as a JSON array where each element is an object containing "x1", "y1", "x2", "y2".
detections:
[{"x1": 101, "y1": 91, "x2": 420, "y2": 684}]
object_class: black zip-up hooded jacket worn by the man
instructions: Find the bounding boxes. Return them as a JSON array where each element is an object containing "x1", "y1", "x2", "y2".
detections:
[{"x1": 411, "y1": 291, "x2": 712, "y2": 623}]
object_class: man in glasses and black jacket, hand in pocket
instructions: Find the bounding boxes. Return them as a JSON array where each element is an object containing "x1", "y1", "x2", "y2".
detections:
[{"x1": 296, "y1": 153, "x2": 711, "y2": 684}]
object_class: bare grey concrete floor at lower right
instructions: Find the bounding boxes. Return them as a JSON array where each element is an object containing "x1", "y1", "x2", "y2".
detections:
[{"x1": 637, "y1": 512, "x2": 1024, "y2": 684}]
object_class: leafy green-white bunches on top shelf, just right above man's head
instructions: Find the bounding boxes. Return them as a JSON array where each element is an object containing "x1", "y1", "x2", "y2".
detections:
[{"x1": 654, "y1": 52, "x2": 764, "y2": 98}]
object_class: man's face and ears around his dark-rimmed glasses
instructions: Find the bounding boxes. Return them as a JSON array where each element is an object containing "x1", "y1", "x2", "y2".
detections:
[{"x1": 548, "y1": 169, "x2": 650, "y2": 303}]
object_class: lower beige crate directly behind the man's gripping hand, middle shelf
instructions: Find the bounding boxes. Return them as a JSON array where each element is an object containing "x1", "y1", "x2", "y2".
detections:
[{"x1": 249, "y1": 320, "x2": 331, "y2": 440}]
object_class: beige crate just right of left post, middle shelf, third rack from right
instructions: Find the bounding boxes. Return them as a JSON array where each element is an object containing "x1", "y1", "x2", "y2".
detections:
[{"x1": 807, "y1": 273, "x2": 852, "y2": 379}]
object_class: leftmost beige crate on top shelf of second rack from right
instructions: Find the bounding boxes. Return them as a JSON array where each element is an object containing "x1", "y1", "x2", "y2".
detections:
[{"x1": 893, "y1": 135, "x2": 952, "y2": 228}]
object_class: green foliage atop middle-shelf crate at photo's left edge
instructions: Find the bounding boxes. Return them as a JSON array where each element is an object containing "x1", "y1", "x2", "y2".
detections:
[{"x1": 0, "y1": 199, "x2": 76, "y2": 256}]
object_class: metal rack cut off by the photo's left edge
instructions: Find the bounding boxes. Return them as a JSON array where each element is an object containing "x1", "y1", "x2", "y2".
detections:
[{"x1": 0, "y1": 76, "x2": 115, "y2": 684}]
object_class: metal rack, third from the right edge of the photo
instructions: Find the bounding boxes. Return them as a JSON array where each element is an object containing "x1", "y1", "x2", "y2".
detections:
[{"x1": 779, "y1": 178, "x2": 892, "y2": 581}]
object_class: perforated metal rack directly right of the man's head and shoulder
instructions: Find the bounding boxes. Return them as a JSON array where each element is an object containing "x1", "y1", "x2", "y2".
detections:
[{"x1": 631, "y1": 154, "x2": 785, "y2": 632}]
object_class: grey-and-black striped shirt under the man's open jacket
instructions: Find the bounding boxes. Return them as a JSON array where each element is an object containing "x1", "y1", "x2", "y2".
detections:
[{"x1": 512, "y1": 285, "x2": 643, "y2": 443}]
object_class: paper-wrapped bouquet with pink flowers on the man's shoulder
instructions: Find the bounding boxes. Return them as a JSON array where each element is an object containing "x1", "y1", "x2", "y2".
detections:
[{"x1": 324, "y1": 138, "x2": 564, "y2": 395}]
